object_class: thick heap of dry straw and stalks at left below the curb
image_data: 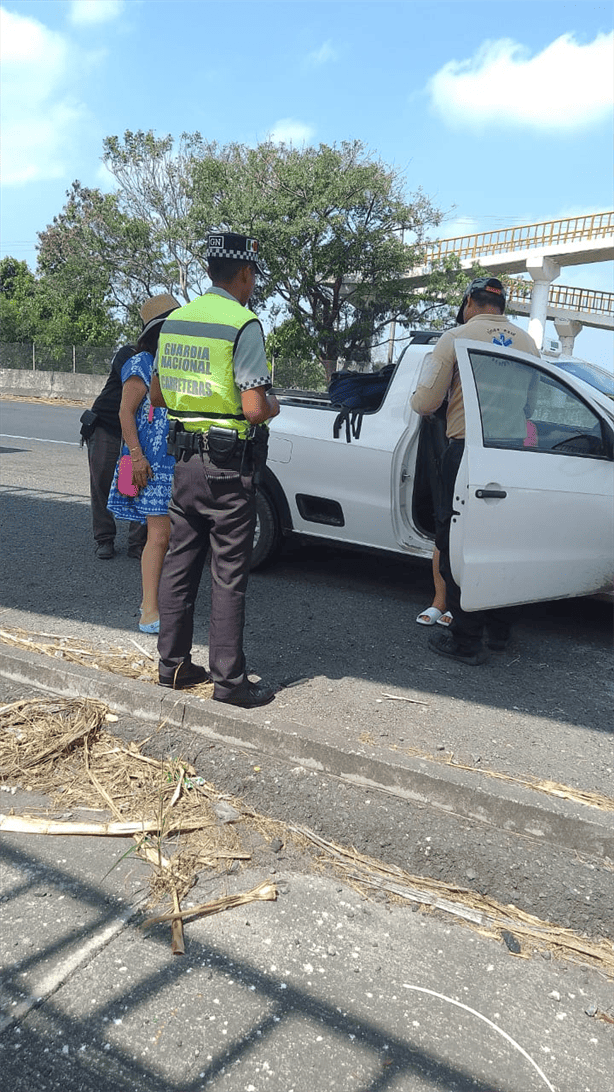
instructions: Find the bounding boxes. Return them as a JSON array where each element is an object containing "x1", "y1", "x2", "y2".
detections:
[{"x1": 0, "y1": 698, "x2": 265, "y2": 905}]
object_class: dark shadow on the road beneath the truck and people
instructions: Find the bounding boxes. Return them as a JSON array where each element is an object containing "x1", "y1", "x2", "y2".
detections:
[{"x1": 0, "y1": 482, "x2": 612, "y2": 733}]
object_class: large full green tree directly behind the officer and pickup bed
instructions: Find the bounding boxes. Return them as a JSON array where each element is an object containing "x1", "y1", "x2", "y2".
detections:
[{"x1": 190, "y1": 141, "x2": 441, "y2": 371}]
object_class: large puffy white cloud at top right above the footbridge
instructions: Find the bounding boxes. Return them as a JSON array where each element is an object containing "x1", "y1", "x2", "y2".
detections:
[{"x1": 427, "y1": 34, "x2": 614, "y2": 132}]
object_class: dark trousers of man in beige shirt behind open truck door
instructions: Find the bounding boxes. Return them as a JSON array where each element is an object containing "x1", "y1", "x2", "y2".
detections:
[{"x1": 435, "y1": 440, "x2": 511, "y2": 652}]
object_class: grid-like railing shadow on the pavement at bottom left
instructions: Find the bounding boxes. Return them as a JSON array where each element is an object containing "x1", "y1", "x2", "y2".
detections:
[{"x1": 0, "y1": 838, "x2": 513, "y2": 1092}]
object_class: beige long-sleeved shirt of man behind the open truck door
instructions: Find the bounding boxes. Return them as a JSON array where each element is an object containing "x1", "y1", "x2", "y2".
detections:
[{"x1": 411, "y1": 314, "x2": 540, "y2": 440}]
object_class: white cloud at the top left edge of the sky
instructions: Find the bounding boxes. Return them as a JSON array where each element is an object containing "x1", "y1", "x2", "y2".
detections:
[{"x1": 0, "y1": 8, "x2": 86, "y2": 186}]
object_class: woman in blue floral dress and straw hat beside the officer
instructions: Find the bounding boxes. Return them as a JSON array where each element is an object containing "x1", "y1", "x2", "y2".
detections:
[{"x1": 107, "y1": 294, "x2": 179, "y2": 633}]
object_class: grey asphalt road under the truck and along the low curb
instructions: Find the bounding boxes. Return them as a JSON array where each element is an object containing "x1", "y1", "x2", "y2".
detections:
[{"x1": 0, "y1": 403, "x2": 614, "y2": 936}]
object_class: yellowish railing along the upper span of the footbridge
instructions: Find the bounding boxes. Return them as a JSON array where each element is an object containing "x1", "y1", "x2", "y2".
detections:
[{"x1": 426, "y1": 212, "x2": 614, "y2": 263}]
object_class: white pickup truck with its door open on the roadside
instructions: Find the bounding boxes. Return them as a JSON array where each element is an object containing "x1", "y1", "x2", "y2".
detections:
[{"x1": 252, "y1": 332, "x2": 614, "y2": 610}]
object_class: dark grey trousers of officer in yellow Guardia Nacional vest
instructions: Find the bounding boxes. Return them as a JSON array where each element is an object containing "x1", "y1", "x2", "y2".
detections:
[{"x1": 157, "y1": 454, "x2": 256, "y2": 698}]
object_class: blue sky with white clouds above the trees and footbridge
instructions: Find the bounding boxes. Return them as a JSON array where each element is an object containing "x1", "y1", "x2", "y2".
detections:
[{"x1": 1, "y1": 0, "x2": 614, "y2": 367}]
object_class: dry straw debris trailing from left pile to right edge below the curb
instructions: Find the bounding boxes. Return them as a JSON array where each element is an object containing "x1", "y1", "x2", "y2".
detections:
[{"x1": 0, "y1": 698, "x2": 614, "y2": 977}]
